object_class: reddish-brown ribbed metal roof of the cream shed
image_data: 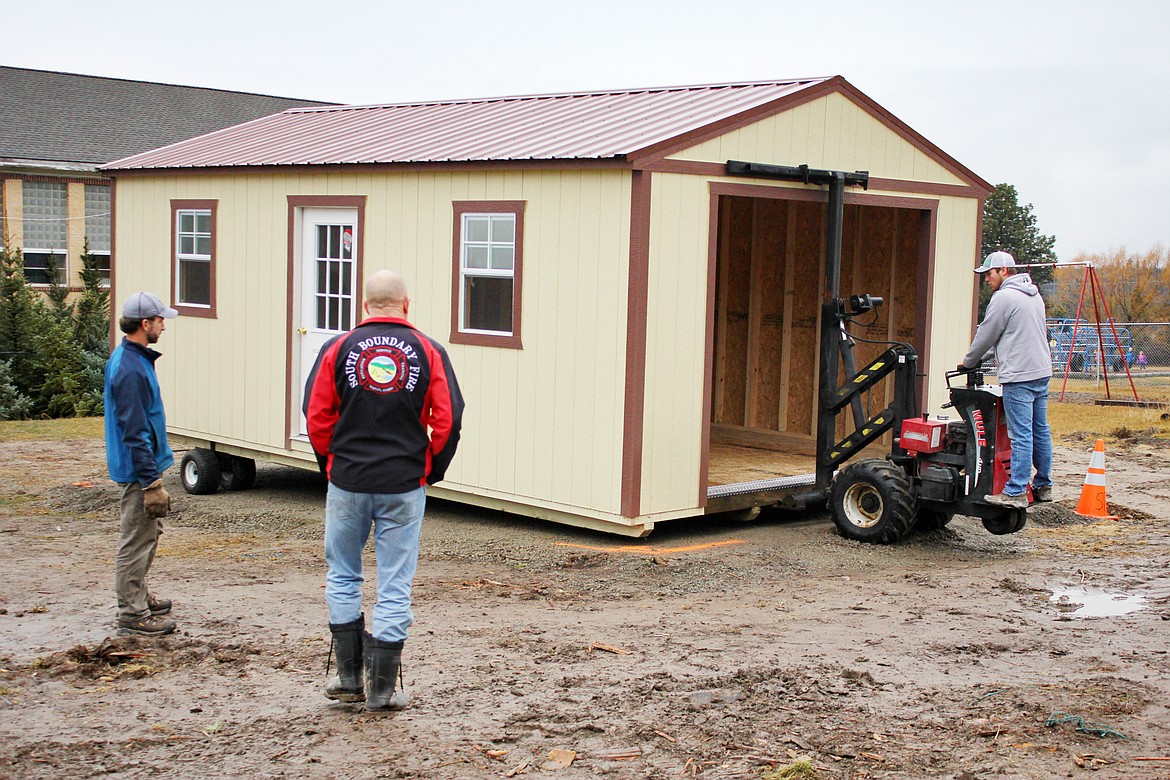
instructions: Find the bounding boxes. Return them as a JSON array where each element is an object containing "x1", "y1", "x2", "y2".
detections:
[{"x1": 103, "y1": 77, "x2": 827, "y2": 170}]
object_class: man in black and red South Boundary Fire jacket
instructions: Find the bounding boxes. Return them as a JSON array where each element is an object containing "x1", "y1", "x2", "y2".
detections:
[{"x1": 304, "y1": 270, "x2": 463, "y2": 712}]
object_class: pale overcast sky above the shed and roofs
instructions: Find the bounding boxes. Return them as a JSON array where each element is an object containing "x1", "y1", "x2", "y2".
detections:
[{"x1": 0, "y1": 0, "x2": 1170, "y2": 260}]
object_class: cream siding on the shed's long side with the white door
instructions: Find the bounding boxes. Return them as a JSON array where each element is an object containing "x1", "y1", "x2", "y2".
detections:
[{"x1": 115, "y1": 170, "x2": 631, "y2": 519}]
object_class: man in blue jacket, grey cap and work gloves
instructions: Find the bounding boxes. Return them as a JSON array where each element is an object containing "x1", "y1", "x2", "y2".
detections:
[{"x1": 105, "y1": 292, "x2": 179, "y2": 636}]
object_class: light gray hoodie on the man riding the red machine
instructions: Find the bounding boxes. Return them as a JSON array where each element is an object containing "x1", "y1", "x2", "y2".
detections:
[{"x1": 963, "y1": 274, "x2": 1052, "y2": 384}]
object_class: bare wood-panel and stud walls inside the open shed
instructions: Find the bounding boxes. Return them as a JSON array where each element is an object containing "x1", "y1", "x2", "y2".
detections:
[{"x1": 711, "y1": 196, "x2": 921, "y2": 437}]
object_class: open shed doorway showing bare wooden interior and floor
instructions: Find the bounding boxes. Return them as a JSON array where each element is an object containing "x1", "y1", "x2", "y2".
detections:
[{"x1": 706, "y1": 187, "x2": 932, "y2": 511}]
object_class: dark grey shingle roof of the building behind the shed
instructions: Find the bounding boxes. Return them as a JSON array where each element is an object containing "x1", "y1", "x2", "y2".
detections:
[{"x1": 0, "y1": 65, "x2": 329, "y2": 170}]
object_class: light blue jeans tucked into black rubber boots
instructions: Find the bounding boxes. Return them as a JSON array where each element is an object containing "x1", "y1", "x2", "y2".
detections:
[{"x1": 325, "y1": 483, "x2": 427, "y2": 642}]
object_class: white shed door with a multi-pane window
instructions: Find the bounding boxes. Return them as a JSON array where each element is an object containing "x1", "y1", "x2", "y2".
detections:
[{"x1": 295, "y1": 208, "x2": 358, "y2": 436}]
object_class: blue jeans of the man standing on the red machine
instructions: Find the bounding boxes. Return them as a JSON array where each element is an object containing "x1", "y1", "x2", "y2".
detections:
[{"x1": 1000, "y1": 379, "x2": 1052, "y2": 496}]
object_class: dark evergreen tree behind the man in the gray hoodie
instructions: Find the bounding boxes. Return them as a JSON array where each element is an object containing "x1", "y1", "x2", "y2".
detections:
[{"x1": 979, "y1": 184, "x2": 1057, "y2": 319}]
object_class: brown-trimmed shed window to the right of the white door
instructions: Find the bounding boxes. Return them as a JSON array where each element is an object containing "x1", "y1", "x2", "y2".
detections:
[{"x1": 450, "y1": 201, "x2": 524, "y2": 350}]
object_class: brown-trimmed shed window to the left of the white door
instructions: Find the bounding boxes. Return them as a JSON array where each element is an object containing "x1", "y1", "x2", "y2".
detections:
[{"x1": 171, "y1": 200, "x2": 216, "y2": 317}]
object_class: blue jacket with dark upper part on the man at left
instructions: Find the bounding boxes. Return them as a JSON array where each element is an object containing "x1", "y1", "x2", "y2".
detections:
[{"x1": 105, "y1": 338, "x2": 174, "y2": 488}]
